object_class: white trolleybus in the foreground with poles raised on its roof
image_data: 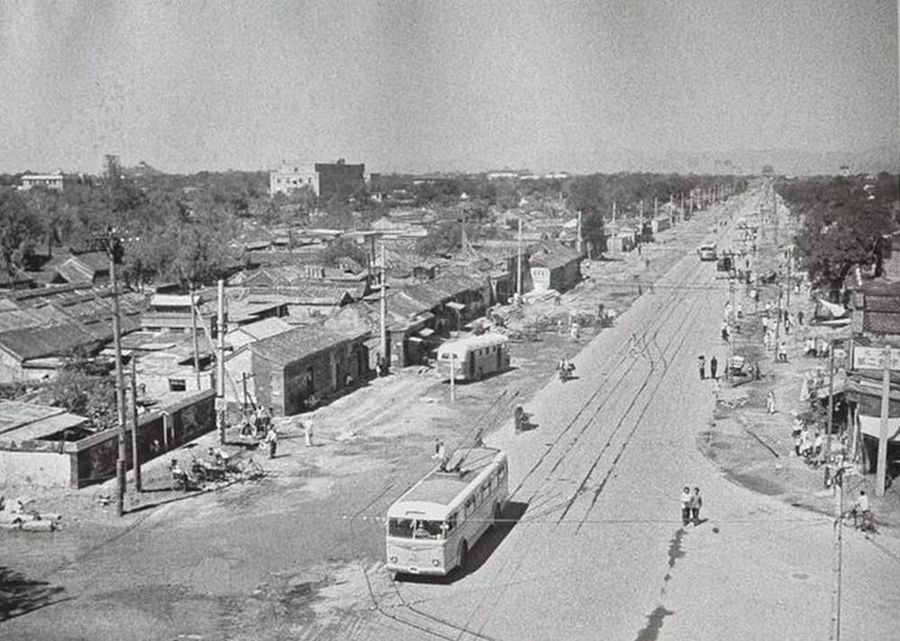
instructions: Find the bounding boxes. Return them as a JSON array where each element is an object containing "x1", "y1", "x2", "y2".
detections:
[{"x1": 387, "y1": 447, "x2": 509, "y2": 575}]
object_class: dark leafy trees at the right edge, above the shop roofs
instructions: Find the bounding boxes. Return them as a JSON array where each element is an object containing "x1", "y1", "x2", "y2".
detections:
[{"x1": 776, "y1": 173, "x2": 900, "y2": 301}]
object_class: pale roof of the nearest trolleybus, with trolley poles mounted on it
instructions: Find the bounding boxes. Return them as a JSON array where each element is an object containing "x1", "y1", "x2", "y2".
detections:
[{"x1": 388, "y1": 447, "x2": 505, "y2": 518}]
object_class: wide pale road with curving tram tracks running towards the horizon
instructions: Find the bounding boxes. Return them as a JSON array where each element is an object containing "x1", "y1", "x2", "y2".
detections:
[{"x1": 314, "y1": 188, "x2": 900, "y2": 641}]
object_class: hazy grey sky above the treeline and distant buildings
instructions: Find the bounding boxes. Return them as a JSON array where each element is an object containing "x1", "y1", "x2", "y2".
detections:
[{"x1": 0, "y1": 0, "x2": 900, "y2": 172}]
